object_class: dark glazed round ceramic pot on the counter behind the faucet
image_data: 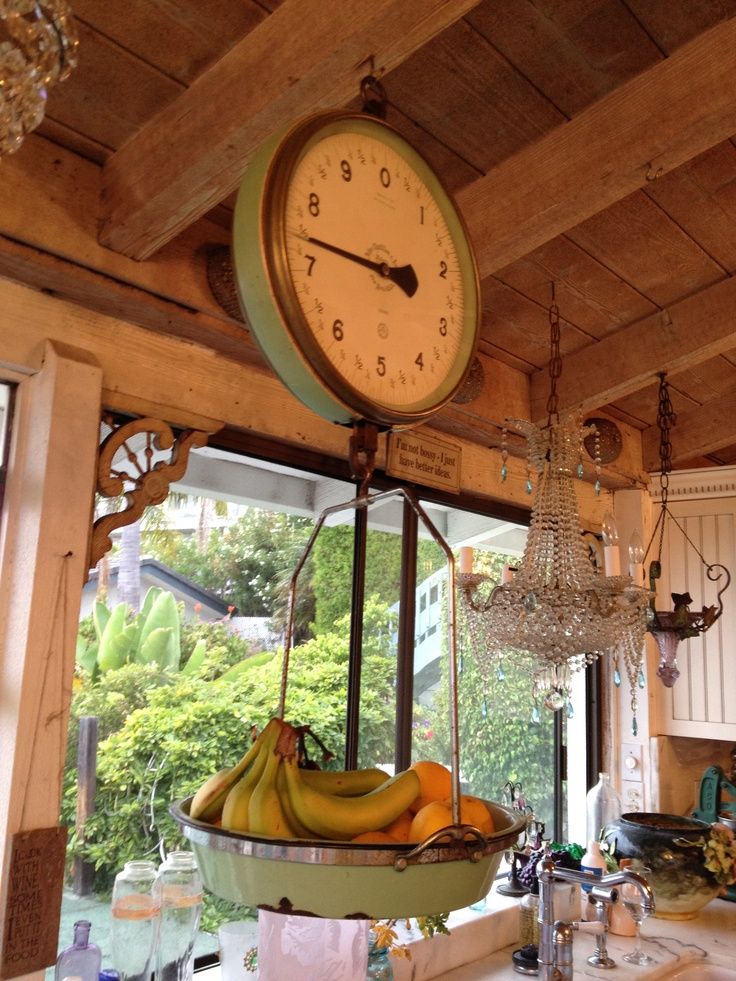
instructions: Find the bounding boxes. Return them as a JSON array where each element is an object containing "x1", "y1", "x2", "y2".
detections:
[{"x1": 603, "y1": 812, "x2": 720, "y2": 920}]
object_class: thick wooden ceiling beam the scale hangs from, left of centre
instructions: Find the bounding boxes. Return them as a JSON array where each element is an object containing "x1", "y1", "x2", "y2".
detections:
[{"x1": 100, "y1": 0, "x2": 486, "y2": 259}]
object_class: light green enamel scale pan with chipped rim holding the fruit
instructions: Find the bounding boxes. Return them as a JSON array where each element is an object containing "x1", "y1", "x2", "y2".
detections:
[{"x1": 170, "y1": 797, "x2": 526, "y2": 920}]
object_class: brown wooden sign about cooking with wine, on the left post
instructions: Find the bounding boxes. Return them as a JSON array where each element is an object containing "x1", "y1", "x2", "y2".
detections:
[{"x1": 0, "y1": 827, "x2": 71, "y2": 981}]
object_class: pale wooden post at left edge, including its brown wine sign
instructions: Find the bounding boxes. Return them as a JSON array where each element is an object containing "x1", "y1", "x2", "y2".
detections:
[{"x1": 0, "y1": 342, "x2": 102, "y2": 981}]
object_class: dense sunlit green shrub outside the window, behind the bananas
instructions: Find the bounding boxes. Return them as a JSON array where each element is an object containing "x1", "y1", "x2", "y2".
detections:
[{"x1": 62, "y1": 600, "x2": 395, "y2": 925}]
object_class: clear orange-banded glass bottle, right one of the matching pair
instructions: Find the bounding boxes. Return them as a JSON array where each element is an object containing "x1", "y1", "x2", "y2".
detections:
[{"x1": 156, "y1": 852, "x2": 202, "y2": 981}]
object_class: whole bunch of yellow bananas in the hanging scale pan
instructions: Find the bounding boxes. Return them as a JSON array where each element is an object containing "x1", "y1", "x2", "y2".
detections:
[{"x1": 190, "y1": 719, "x2": 420, "y2": 841}]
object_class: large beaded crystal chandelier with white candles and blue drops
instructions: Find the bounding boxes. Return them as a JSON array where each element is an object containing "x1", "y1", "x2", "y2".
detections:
[{"x1": 458, "y1": 289, "x2": 649, "y2": 728}]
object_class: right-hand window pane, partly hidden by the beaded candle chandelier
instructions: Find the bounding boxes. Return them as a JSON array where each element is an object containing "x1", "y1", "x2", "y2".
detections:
[{"x1": 413, "y1": 510, "x2": 555, "y2": 833}]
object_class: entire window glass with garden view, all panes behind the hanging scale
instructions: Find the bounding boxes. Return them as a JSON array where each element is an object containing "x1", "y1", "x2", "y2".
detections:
[{"x1": 60, "y1": 450, "x2": 583, "y2": 964}]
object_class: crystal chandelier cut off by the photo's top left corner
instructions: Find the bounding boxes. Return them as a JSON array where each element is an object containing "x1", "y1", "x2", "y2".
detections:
[{"x1": 0, "y1": 0, "x2": 79, "y2": 155}]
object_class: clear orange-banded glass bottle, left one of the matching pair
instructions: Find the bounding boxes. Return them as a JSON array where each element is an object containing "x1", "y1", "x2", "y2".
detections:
[{"x1": 112, "y1": 861, "x2": 161, "y2": 981}]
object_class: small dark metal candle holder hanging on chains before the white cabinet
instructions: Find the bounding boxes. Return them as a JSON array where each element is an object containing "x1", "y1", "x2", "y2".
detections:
[{"x1": 644, "y1": 372, "x2": 731, "y2": 688}]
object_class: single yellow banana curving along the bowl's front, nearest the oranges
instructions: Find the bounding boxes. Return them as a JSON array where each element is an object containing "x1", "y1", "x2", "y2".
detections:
[{"x1": 283, "y1": 758, "x2": 420, "y2": 841}]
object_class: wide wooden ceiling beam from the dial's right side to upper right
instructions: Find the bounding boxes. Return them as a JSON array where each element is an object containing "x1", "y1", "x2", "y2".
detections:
[{"x1": 457, "y1": 19, "x2": 736, "y2": 276}]
